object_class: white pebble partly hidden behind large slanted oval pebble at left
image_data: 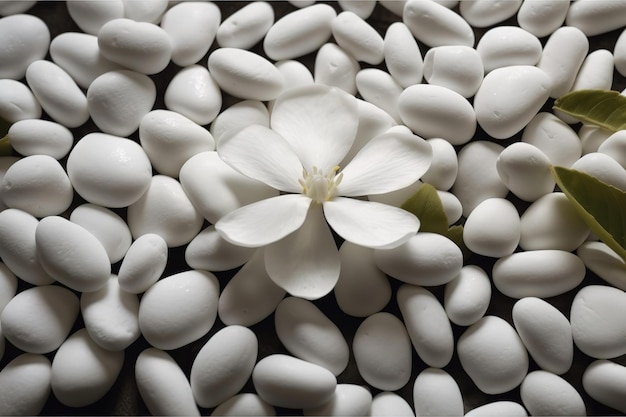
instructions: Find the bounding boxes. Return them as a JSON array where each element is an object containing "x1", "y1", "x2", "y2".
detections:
[{"x1": 69, "y1": 203, "x2": 132, "y2": 264}]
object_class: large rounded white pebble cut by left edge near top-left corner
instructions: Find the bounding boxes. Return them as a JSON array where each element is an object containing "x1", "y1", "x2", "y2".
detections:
[{"x1": 0, "y1": 14, "x2": 50, "y2": 80}]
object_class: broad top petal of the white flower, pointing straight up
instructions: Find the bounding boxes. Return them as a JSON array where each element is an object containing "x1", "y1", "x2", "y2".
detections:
[{"x1": 270, "y1": 84, "x2": 359, "y2": 172}]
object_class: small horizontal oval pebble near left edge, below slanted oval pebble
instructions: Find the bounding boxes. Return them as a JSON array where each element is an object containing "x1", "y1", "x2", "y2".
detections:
[{"x1": 7, "y1": 119, "x2": 74, "y2": 160}]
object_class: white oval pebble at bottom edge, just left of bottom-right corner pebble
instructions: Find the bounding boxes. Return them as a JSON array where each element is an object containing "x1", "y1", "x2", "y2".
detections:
[{"x1": 520, "y1": 371, "x2": 587, "y2": 416}]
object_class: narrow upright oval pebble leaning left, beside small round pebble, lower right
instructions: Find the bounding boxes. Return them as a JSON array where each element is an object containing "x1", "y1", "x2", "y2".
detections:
[{"x1": 396, "y1": 284, "x2": 454, "y2": 368}]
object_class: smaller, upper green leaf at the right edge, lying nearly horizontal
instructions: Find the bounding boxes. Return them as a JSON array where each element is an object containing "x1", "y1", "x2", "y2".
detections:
[{"x1": 553, "y1": 90, "x2": 626, "y2": 132}]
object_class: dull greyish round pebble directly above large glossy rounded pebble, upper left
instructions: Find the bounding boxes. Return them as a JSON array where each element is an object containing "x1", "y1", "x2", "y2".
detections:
[{"x1": 87, "y1": 70, "x2": 156, "y2": 136}]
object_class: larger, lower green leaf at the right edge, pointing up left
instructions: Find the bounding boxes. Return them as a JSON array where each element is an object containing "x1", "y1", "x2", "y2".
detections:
[{"x1": 552, "y1": 167, "x2": 626, "y2": 261}]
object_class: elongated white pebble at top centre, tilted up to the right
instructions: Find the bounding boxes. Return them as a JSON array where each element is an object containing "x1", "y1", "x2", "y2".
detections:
[{"x1": 263, "y1": 4, "x2": 337, "y2": 61}]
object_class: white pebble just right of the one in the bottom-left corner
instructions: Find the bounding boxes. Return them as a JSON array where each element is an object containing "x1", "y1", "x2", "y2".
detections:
[{"x1": 50, "y1": 328, "x2": 124, "y2": 407}]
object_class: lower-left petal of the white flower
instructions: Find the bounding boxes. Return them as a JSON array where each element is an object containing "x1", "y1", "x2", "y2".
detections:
[{"x1": 215, "y1": 194, "x2": 311, "y2": 247}]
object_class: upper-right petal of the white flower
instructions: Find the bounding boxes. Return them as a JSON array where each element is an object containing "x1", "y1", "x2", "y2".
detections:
[{"x1": 337, "y1": 128, "x2": 433, "y2": 197}]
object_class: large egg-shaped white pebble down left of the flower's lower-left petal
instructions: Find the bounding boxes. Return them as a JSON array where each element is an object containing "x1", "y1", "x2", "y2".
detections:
[{"x1": 139, "y1": 270, "x2": 219, "y2": 350}]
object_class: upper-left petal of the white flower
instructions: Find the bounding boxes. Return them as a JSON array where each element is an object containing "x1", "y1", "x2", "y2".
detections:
[{"x1": 217, "y1": 125, "x2": 302, "y2": 193}]
